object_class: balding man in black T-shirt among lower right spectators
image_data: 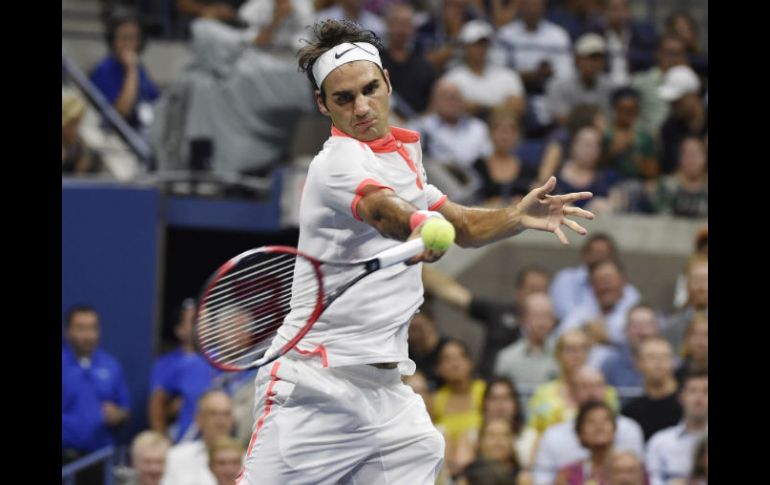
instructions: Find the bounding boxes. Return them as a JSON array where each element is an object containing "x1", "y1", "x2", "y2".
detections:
[{"x1": 621, "y1": 337, "x2": 682, "y2": 441}]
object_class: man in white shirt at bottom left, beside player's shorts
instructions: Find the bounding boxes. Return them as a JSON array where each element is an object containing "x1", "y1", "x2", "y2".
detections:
[{"x1": 162, "y1": 390, "x2": 234, "y2": 485}]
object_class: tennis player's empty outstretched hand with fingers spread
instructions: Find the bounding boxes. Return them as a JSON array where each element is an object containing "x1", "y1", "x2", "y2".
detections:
[{"x1": 518, "y1": 176, "x2": 594, "y2": 245}]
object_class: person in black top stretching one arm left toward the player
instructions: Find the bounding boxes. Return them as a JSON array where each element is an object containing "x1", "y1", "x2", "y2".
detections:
[{"x1": 422, "y1": 265, "x2": 551, "y2": 378}]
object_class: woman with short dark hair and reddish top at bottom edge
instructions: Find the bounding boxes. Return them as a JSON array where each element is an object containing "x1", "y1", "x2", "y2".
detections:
[{"x1": 554, "y1": 401, "x2": 617, "y2": 485}]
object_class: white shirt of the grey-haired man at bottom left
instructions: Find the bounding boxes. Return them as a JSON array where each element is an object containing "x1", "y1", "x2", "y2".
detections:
[{"x1": 161, "y1": 440, "x2": 217, "y2": 485}]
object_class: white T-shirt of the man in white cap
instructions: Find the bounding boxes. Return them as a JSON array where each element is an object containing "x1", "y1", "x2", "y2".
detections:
[{"x1": 444, "y1": 64, "x2": 524, "y2": 107}]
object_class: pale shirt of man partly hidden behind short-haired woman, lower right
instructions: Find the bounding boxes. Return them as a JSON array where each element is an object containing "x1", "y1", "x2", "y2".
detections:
[{"x1": 533, "y1": 416, "x2": 644, "y2": 485}]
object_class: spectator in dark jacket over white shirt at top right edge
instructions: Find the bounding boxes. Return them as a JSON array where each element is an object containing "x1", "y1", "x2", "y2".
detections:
[{"x1": 596, "y1": 0, "x2": 658, "y2": 86}]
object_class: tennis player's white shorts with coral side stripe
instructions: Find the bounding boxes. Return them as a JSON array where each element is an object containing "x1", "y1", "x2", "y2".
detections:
[{"x1": 236, "y1": 354, "x2": 444, "y2": 485}]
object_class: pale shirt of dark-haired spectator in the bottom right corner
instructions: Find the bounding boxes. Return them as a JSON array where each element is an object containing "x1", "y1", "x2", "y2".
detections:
[{"x1": 645, "y1": 422, "x2": 708, "y2": 485}]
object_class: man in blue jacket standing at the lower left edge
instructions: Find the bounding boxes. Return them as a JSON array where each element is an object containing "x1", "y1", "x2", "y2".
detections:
[{"x1": 61, "y1": 305, "x2": 131, "y2": 485}]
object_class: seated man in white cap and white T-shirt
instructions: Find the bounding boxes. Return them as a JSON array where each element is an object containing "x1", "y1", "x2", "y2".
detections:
[{"x1": 444, "y1": 20, "x2": 525, "y2": 118}]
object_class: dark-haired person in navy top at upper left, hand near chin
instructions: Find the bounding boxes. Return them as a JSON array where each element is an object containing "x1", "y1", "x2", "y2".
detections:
[{"x1": 91, "y1": 13, "x2": 159, "y2": 130}]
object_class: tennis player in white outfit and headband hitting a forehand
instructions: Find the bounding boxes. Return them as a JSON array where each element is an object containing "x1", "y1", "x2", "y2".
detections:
[{"x1": 238, "y1": 20, "x2": 593, "y2": 485}]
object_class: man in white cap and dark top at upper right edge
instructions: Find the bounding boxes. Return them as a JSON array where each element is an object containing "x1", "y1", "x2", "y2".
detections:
[{"x1": 658, "y1": 66, "x2": 709, "y2": 174}]
